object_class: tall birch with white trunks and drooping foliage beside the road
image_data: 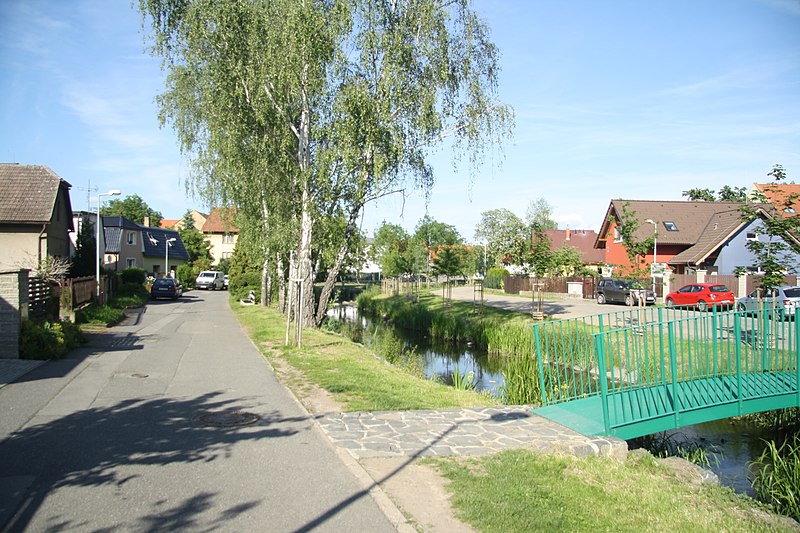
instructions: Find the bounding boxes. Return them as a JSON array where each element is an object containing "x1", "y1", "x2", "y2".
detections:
[{"x1": 139, "y1": 0, "x2": 513, "y2": 325}]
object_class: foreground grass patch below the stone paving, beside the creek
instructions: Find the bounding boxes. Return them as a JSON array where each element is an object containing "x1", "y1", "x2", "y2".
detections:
[{"x1": 434, "y1": 450, "x2": 796, "y2": 533}]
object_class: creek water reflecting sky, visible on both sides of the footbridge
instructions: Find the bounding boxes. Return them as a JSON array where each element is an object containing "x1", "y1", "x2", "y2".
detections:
[{"x1": 328, "y1": 305, "x2": 784, "y2": 496}]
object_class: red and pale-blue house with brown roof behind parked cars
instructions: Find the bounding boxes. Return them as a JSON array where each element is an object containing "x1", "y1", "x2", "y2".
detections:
[{"x1": 595, "y1": 200, "x2": 800, "y2": 274}]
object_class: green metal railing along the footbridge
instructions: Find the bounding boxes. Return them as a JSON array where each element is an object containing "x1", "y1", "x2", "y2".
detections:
[{"x1": 533, "y1": 305, "x2": 800, "y2": 405}]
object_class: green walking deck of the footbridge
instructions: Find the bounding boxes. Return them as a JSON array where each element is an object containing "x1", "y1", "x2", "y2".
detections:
[{"x1": 534, "y1": 372, "x2": 798, "y2": 439}]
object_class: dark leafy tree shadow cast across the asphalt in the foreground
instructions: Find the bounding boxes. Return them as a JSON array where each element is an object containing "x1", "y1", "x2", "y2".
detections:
[{"x1": 0, "y1": 393, "x2": 300, "y2": 531}]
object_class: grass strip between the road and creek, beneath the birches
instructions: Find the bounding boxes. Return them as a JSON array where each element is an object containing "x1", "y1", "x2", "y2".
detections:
[{"x1": 233, "y1": 304, "x2": 497, "y2": 411}]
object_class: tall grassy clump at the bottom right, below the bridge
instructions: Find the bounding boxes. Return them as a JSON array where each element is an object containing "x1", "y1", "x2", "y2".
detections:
[{"x1": 752, "y1": 434, "x2": 800, "y2": 520}]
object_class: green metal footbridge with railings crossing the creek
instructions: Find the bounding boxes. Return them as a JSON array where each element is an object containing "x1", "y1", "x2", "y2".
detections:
[{"x1": 533, "y1": 306, "x2": 800, "y2": 439}]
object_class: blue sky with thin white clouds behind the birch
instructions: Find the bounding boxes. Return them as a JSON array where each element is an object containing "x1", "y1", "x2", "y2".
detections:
[{"x1": 0, "y1": 0, "x2": 800, "y2": 240}]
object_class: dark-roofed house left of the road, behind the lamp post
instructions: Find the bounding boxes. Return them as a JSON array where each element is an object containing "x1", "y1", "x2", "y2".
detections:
[{"x1": 103, "y1": 216, "x2": 189, "y2": 276}]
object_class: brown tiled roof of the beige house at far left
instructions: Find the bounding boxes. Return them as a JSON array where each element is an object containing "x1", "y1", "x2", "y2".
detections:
[{"x1": 0, "y1": 163, "x2": 72, "y2": 225}]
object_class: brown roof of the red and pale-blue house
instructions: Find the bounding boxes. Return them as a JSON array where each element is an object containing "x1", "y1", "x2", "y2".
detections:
[{"x1": 595, "y1": 200, "x2": 768, "y2": 246}]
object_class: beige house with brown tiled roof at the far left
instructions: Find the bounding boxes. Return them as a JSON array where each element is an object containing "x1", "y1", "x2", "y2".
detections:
[{"x1": 0, "y1": 163, "x2": 74, "y2": 270}]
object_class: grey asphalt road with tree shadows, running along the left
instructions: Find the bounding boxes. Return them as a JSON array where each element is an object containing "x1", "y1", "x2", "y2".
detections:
[{"x1": 0, "y1": 291, "x2": 395, "y2": 532}]
